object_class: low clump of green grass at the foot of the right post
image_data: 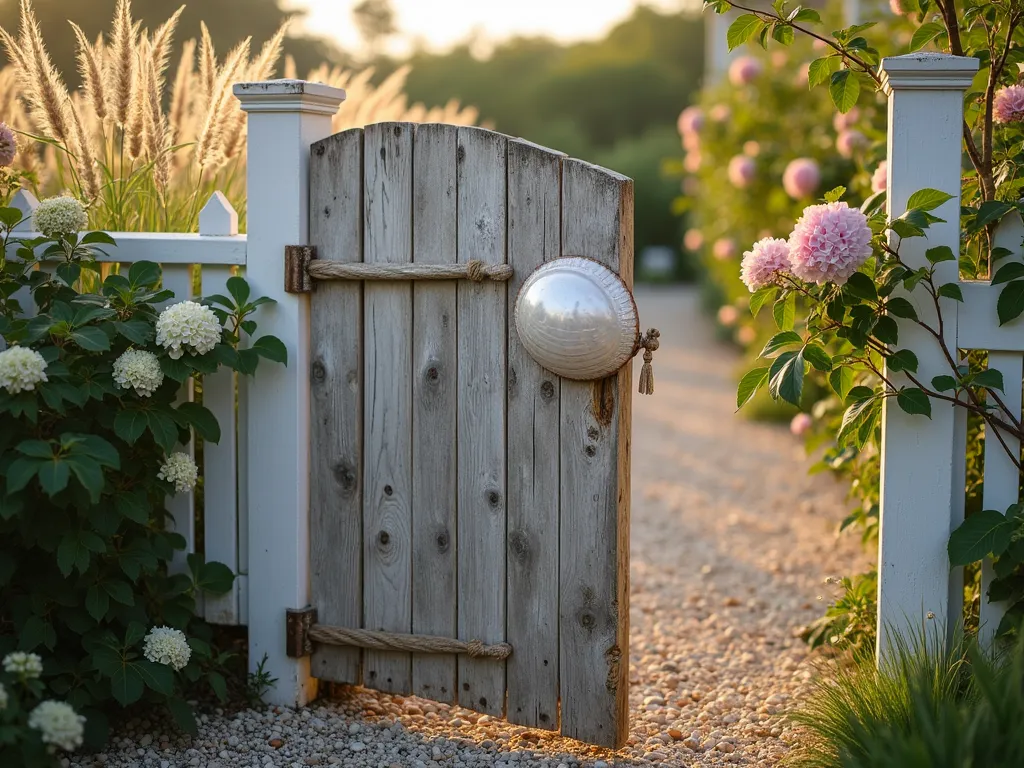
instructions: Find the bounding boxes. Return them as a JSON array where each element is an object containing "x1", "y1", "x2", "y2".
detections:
[{"x1": 786, "y1": 636, "x2": 1024, "y2": 768}]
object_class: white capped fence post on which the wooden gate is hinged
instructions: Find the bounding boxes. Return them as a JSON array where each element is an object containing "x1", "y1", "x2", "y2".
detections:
[{"x1": 234, "y1": 80, "x2": 345, "y2": 706}]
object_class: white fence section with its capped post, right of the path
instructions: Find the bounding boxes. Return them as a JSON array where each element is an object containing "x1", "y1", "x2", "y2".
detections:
[{"x1": 879, "y1": 53, "x2": 1024, "y2": 657}]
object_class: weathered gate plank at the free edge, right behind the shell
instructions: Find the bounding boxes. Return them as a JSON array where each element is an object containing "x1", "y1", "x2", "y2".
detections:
[{"x1": 559, "y1": 160, "x2": 633, "y2": 748}]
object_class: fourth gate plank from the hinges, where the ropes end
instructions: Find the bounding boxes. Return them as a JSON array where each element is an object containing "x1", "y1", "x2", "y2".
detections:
[{"x1": 457, "y1": 128, "x2": 508, "y2": 715}]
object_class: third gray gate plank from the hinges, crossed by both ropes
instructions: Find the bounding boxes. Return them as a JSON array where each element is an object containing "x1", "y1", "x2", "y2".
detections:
[{"x1": 413, "y1": 125, "x2": 459, "y2": 701}]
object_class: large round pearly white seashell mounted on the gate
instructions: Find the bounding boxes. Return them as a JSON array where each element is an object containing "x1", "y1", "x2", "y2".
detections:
[{"x1": 515, "y1": 256, "x2": 640, "y2": 380}]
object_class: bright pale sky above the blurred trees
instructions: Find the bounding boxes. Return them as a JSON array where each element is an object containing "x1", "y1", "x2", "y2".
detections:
[{"x1": 287, "y1": 0, "x2": 681, "y2": 53}]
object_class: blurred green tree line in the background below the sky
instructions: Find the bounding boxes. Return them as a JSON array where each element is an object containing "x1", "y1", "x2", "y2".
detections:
[{"x1": 0, "y1": 0, "x2": 703, "y2": 266}]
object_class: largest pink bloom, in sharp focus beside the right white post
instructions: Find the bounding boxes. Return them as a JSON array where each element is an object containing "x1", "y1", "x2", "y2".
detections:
[{"x1": 790, "y1": 203, "x2": 871, "y2": 286}]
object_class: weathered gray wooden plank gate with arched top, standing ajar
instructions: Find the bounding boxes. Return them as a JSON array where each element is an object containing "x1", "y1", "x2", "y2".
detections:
[{"x1": 309, "y1": 123, "x2": 633, "y2": 745}]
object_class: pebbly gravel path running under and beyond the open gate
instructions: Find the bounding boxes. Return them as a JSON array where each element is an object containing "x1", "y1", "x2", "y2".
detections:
[{"x1": 66, "y1": 289, "x2": 866, "y2": 768}]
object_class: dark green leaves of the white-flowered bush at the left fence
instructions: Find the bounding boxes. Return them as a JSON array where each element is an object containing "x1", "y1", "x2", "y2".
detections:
[{"x1": 0, "y1": 208, "x2": 286, "y2": 753}]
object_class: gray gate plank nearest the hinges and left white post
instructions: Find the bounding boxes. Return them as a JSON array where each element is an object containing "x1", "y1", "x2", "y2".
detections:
[{"x1": 309, "y1": 129, "x2": 362, "y2": 683}]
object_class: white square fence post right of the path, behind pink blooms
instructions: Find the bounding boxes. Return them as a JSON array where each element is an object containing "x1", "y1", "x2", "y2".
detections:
[{"x1": 878, "y1": 53, "x2": 978, "y2": 659}]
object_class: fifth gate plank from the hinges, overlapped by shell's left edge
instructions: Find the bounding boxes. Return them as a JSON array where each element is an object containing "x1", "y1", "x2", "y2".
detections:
[{"x1": 506, "y1": 140, "x2": 563, "y2": 730}]
